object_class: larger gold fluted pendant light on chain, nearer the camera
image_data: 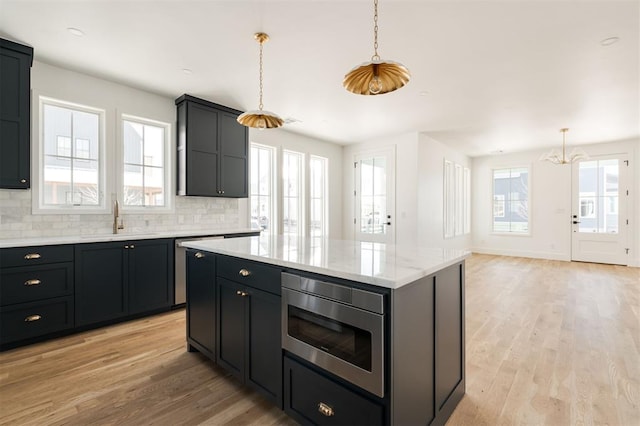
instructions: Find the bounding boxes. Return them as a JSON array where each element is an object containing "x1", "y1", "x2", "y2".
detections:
[{"x1": 342, "y1": 0, "x2": 411, "y2": 95}]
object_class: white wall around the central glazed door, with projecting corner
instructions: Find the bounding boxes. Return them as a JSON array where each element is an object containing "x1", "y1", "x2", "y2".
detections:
[{"x1": 343, "y1": 133, "x2": 471, "y2": 248}]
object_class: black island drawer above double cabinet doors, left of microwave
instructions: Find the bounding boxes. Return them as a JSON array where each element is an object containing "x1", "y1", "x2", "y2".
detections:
[{"x1": 217, "y1": 256, "x2": 281, "y2": 295}]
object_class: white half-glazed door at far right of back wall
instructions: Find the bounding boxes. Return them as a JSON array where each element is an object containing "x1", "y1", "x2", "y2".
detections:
[{"x1": 571, "y1": 155, "x2": 629, "y2": 265}]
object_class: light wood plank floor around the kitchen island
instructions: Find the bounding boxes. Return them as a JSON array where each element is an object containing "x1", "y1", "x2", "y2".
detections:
[{"x1": 0, "y1": 255, "x2": 640, "y2": 425}]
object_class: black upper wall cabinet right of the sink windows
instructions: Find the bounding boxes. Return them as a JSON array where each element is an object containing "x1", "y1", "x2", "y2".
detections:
[{"x1": 176, "y1": 95, "x2": 249, "y2": 198}]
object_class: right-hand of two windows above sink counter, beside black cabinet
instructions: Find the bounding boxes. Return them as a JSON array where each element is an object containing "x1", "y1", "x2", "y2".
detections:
[{"x1": 122, "y1": 116, "x2": 169, "y2": 208}]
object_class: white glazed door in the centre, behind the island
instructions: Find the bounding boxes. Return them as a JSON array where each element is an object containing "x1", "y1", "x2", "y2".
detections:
[{"x1": 353, "y1": 148, "x2": 396, "y2": 244}]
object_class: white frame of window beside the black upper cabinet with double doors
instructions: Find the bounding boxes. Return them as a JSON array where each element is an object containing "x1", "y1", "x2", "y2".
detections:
[{"x1": 115, "y1": 113, "x2": 175, "y2": 213}]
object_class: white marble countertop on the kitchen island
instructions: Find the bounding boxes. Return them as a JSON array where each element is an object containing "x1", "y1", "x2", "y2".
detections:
[{"x1": 184, "y1": 235, "x2": 471, "y2": 289}]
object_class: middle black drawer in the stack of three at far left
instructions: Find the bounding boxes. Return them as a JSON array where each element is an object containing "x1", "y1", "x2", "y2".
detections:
[{"x1": 0, "y1": 262, "x2": 73, "y2": 306}]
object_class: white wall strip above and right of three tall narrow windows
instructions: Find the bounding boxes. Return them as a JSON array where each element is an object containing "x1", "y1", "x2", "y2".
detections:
[{"x1": 245, "y1": 129, "x2": 342, "y2": 238}]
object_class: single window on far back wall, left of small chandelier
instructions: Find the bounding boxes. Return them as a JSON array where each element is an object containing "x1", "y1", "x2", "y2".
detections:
[{"x1": 493, "y1": 167, "x2": 529, "y2": 234}]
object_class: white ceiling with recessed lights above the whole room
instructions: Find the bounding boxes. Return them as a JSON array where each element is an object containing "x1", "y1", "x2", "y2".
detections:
[{"x1": 0, "y1": 0, "x2": 640, "y2": 156}]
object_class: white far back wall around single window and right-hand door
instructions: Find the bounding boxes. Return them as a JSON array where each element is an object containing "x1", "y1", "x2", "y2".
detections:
[{"x1": 472, "y1": 140, "x2": 640, "y2": 266}]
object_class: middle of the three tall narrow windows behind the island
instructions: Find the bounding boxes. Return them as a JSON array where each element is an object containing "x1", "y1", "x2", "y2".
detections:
[{"x1": 282, "y1": 151, "x2": 303, "y2": 235}]
